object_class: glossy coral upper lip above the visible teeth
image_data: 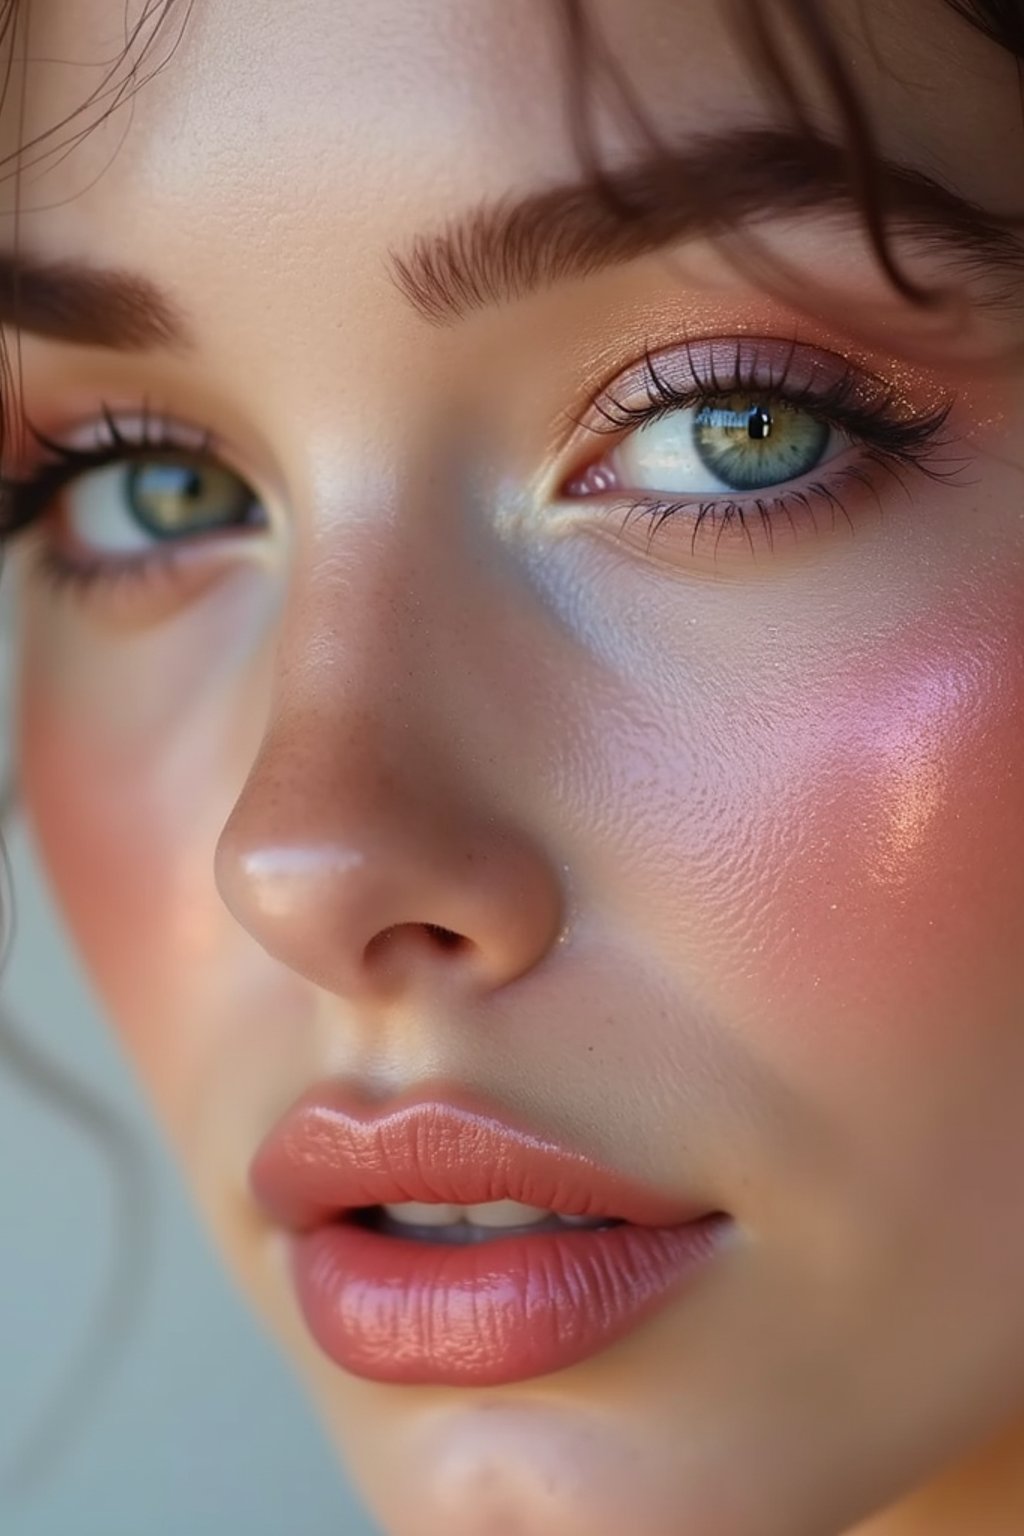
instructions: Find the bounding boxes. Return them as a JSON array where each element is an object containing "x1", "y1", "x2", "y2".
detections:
[{"x1": 250, "y1": 1086, "x2": 711, "y2": 1229}]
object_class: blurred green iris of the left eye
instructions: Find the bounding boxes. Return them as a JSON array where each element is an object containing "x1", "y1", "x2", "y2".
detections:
[{"x1": 124, "y1": 453, "x2": 255, "y2": 539}]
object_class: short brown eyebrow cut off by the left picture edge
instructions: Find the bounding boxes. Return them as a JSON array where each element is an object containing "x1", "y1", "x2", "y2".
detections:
[{"x1": 0, "y1": 252, "x2": 187, "y2": 352}]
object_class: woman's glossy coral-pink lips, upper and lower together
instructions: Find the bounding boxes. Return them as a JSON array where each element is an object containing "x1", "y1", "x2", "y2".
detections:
[{"x1": 250, "y1": 1089, "x2": 729, "y2": 1385}]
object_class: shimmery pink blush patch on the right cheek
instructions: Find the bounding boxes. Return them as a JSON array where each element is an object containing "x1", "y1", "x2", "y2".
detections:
[{"x1": 721, "y1": 601, "x2": 1024, "y2": 1060}]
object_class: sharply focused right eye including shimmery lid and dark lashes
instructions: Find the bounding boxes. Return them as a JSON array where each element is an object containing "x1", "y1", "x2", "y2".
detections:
[{"x1": 559, "y1": 336, "x2": 967, "y2": 561}]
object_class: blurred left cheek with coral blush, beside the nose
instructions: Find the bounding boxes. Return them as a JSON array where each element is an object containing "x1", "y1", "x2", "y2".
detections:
[{"x1": 18, "y1": 574, "x2": 280, "y2": 1117}]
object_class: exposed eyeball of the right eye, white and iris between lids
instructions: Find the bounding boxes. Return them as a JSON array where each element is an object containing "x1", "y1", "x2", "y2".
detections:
[{"x1": 603, "y1": 393, "x2": 846, "y2": 496}]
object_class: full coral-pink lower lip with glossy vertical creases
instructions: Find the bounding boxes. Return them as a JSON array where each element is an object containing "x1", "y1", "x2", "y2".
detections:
[{"x1": 292, "y1": 1212, "x2": 731, "y2": 1387}]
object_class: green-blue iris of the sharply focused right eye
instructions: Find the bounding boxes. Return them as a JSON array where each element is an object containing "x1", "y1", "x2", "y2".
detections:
[{"x1": 694, "y1": 395, "x2": 831, "y2": 490}]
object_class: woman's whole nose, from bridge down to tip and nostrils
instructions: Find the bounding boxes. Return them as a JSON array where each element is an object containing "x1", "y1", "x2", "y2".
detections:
[{"x1": 216, "y1": 509, "x2": 562, "y2": 998}]
